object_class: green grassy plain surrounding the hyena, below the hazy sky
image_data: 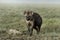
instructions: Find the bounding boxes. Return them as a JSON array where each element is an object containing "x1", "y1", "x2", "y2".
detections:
[{"x1": 0, "y1": 5, "x2": 60, "y2": 40}]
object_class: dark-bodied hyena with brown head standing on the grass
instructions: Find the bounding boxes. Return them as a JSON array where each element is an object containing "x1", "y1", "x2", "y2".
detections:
[{"x1": 24, "y1": 10, "x2": 42, "y2": 36}]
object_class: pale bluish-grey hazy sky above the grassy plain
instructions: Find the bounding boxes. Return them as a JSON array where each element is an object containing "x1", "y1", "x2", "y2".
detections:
[{"x1": 0, "y1": 0, "x2": 60, "y2": 4}]
